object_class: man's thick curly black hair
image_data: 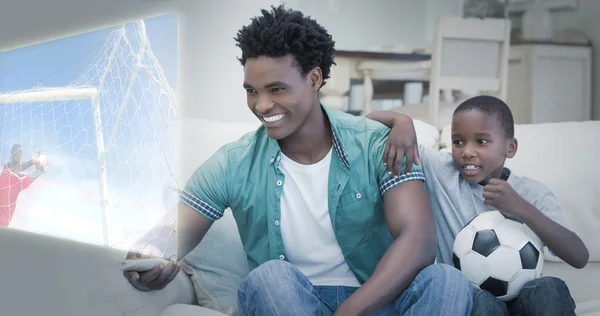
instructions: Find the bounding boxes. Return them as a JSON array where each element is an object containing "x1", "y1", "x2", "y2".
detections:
[{"x1": 235, "y1": 6, "x2": 335, "y2": 86}]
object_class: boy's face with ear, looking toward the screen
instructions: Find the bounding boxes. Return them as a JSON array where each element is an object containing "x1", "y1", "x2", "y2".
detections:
[{"x1": 452, "y1": 111, "x2": 517, "y2": 184}]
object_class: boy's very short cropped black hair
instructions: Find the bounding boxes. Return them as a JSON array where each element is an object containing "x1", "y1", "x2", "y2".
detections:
[{"x1": 453, "y1": 95, "x2": 515, "y2": 139}]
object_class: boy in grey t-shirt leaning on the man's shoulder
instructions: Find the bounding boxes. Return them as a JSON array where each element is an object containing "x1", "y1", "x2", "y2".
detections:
[{"x1": 369, "y1": 96, "x2": 589, "y2": 315}]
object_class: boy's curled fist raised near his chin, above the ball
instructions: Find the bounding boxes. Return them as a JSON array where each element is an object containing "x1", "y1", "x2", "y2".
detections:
[{"x1": 483, "y1": 178, "x2": 521, "y2": 216}]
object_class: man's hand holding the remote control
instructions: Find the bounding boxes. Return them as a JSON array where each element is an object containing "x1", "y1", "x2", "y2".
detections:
[{"x1": 123, "y1": 252, "x2": 181, "y2": 291}]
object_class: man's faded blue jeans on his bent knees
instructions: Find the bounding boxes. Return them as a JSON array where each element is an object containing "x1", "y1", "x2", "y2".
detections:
[{"x1": 238, "y1": 260, "x2": 473, "y2": 316}]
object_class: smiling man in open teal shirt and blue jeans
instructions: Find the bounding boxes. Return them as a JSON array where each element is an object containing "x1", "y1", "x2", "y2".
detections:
[{"x1": 126, "y1": 7, "x2": 472, "y2": 315}]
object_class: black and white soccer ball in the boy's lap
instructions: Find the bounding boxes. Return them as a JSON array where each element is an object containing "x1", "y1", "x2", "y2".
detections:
[{"x1": 452, "y1": 211, "x2": 544, "y2": 301}]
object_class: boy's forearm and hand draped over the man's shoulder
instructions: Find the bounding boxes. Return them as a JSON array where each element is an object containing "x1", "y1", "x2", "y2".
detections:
[{"x1": 367, "y1": 111, "x2": 421, "y2": 176}]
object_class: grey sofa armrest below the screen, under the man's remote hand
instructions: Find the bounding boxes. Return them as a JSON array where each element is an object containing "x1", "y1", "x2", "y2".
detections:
[{"x1": 0, "y1": 228, "x2": 195, "y2": 316}]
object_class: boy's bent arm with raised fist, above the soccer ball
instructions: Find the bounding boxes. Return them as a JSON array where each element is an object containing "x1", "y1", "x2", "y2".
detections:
[{"x1": 484, "y1": 179, "x2": 589, "y2": 269}]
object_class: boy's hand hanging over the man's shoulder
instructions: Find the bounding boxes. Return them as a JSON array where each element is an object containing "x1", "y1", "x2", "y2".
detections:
[{"x1": 383, "y1": 116, "x2": 421, "y2": 176}]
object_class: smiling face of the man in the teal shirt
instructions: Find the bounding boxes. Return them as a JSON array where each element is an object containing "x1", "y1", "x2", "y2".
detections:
[{"x1": 244, "y1": 56, "x2": 322, "y2": 140}]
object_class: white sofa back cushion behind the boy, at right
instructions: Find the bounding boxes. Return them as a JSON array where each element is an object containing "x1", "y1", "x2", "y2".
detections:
[{"x1": 440, "y1": 121, "x2": 600, "y2": 262}]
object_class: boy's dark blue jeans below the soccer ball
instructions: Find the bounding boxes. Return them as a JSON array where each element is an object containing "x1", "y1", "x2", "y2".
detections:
[{"x1": 471, "y1": 276, "x2": 575, "y2": 316}]
